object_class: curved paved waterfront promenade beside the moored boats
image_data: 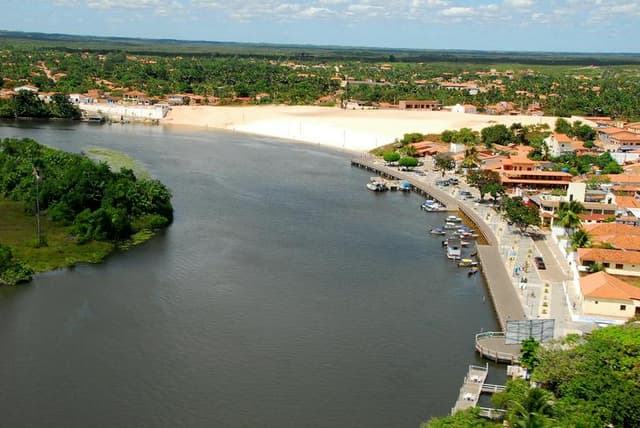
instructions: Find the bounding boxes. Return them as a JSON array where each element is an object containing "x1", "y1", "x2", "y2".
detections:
[{"x1": 351, "y1": 155, "x2": 592, "y2": 337}]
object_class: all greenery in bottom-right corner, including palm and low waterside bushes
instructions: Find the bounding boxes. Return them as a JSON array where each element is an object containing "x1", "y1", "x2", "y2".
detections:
[{"x1": 422, "y1": 321, "x2": 640, "y2": 428}]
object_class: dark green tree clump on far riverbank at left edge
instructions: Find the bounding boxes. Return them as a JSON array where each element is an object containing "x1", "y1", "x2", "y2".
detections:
[{"x1": 0, "y1": 91, "x2": 81, "y2": 120}]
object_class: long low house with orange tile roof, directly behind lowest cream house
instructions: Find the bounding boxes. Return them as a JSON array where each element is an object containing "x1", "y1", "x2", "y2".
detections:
[{"x1": 578, "y1": 248, "x2": 640, "y2": 276}]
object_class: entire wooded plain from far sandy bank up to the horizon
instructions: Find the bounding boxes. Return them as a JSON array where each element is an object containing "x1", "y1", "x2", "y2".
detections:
[{"x1": 0, "y1": 32, "x2": 640, "y2": 121}]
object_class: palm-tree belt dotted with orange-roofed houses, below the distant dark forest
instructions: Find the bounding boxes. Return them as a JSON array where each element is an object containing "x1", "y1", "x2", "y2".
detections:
[{"x1": 0, "y1": 44, "x2": 640, "y2": 121}]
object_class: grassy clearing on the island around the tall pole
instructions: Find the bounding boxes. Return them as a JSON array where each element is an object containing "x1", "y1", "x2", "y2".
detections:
[{"x1": 0, "y1": 198, "x2": 114, "y2": 272}]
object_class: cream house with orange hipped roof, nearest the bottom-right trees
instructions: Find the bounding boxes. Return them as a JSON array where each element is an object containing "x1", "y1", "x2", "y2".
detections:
[{"x1": 580, "y1": 272, "x2": 640, "y2": 319}]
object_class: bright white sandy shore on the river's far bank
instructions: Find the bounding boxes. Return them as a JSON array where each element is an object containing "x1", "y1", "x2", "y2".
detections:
[{"x1": 161, "y1": 106, "x2": 556, "y2": 152}]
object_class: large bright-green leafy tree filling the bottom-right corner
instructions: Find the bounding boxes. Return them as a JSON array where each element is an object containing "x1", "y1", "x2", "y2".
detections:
[{"x1": 532, "y1": 322, "x2": 640, "y2": 427}]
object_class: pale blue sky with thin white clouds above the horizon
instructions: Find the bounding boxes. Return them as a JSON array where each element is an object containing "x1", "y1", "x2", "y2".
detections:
[{"x1": 0, "y1": 0, "x2": 640, "y2": 52}]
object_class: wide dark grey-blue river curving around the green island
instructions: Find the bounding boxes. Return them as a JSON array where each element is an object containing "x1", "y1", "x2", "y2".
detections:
[{"x1": 0, "y1": 122, "x2": 497, "y2": 428}]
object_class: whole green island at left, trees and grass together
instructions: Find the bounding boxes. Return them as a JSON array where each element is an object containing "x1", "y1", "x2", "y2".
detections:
[{"x1": 0, "y1": 138, "x2": 173, "y2": 285}]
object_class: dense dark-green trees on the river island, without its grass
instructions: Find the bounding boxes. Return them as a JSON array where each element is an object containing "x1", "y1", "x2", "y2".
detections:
[{"x1": 0, "y1": 139, "x2": 173, "y2": 247}]
